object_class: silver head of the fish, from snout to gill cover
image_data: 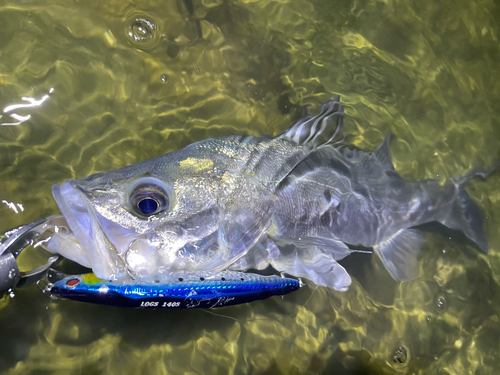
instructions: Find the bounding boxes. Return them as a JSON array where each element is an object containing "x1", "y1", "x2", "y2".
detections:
[{"x1": 53, "y1": 140, "x2": 275, "y2": 281}]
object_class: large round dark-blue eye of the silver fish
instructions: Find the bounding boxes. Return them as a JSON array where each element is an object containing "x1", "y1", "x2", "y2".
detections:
[{"x1": 130, "y1": 181, "x2": 170, "y2": 217}]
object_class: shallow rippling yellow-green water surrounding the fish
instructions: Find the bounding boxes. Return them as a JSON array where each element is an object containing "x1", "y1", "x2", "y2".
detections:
[{"x1": 0, "y1": 0, "x2": 500, "y2": 374}]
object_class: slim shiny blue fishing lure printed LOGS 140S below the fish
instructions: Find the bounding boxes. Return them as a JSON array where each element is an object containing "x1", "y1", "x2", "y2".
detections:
[{"x1": 50, "y1": 271, "x2": 301, "y2": 309}]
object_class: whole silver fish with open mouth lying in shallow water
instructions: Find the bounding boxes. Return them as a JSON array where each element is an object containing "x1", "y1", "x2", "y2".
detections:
[{"x1": 46, "y1": 97, "x2": 499, "y2": 291}]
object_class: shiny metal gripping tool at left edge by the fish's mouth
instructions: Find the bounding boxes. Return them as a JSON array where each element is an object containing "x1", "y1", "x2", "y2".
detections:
[{"x1": 0, "y1": 215, "x2": 64, "y2": 295}]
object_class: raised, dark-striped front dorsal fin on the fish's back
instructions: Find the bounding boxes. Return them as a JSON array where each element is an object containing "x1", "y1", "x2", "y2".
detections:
[{"x1": 280, "y1": 96, "x2": 344, "y2": 148}]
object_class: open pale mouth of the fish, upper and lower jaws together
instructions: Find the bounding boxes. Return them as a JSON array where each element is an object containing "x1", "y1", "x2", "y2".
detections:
[{"x1": 47, "y1": 180, "x2": 127, "y2": 280}]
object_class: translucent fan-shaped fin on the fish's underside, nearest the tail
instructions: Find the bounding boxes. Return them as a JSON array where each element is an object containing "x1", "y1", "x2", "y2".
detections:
[{"x1": 373, "y1": 229, "x2": 424, "y2": 281}]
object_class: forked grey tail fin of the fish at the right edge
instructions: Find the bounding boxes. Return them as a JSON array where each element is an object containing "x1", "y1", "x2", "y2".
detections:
[{"x1": 442, "y1": 161, "x2": 500, "y2": 253}]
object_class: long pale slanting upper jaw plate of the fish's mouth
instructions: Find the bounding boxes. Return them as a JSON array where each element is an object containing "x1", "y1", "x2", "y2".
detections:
[{"x1": 52, "y1": 180, "x2": 127, "y2": 280}]
